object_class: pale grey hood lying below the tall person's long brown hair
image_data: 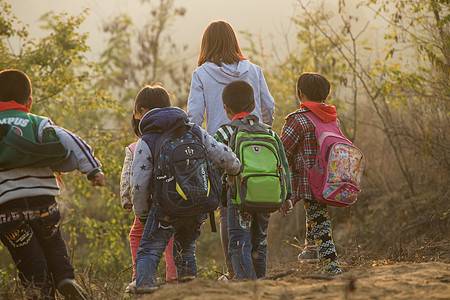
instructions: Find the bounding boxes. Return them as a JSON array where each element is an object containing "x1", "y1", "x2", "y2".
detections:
[{"x1": 202, "y1": 59, "x2": 251, "y2": 84}]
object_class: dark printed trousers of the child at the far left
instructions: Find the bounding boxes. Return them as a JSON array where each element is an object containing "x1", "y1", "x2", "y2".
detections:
[{"x1": 0, "y1": 196, "x2": 74, "y2": 298}]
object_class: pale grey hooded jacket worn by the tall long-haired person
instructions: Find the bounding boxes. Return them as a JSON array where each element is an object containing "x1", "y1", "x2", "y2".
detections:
[{"x1": 187, "y1": 59, "x2": 275, "y2": 135}]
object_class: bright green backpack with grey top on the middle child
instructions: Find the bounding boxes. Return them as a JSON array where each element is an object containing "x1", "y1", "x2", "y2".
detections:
[{"x1": 228, "y1": 115, "x2": 287, "y2": 213}]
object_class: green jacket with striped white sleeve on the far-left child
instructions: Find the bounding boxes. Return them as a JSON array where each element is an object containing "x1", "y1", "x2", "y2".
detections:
[{"x1": 0, "y1": 107, "x2": 101, "y2": 204}]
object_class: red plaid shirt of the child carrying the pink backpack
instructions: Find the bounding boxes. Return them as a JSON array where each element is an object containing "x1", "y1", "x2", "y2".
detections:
[{"x1": 281, "y1": 108, "x2": 318, "y2": 204}]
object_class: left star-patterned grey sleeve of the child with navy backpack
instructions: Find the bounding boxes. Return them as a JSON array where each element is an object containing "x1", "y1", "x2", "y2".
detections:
[{"x1": 130, "y1": 139, "x2": 153, "y2": 216}]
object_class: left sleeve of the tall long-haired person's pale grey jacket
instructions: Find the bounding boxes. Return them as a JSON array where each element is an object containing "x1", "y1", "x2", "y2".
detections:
[{"x1": 187, "y1": 71, "x2": 205, "y2": 126}]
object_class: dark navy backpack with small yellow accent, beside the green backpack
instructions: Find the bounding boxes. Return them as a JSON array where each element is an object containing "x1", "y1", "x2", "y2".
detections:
[{"x1": 152, "y1": 122, "x2": 222, "y2": 231}]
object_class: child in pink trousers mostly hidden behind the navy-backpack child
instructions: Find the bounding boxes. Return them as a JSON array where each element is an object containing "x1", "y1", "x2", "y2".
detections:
[{"x1": 120, "y1": 115, "x2": 177, "y2": 290}]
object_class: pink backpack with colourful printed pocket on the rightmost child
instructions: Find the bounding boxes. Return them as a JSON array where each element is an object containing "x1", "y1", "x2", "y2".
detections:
[{"x1": 300, "y1": 112, "x2": 364, "y2": 207}]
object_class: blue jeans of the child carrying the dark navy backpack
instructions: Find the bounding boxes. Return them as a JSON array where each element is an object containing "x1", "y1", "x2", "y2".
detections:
[{"x1": 136, "y1": 204, "x2": 206, "y2": 287}]
